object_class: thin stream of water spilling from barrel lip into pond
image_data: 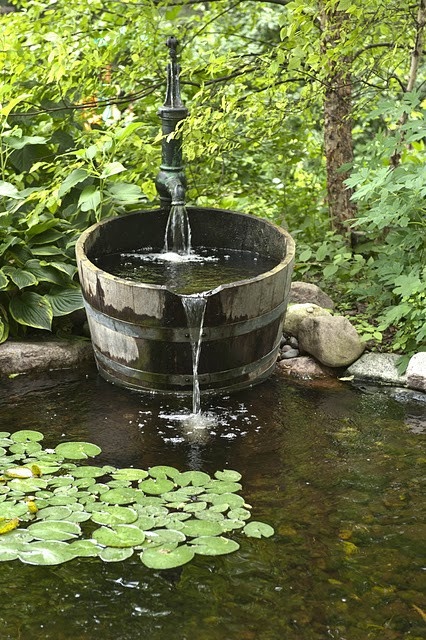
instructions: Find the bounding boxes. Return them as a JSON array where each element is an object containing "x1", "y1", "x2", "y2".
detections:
[{"x1": 181, "y1": 294, "x2": 207, "y2": 416}]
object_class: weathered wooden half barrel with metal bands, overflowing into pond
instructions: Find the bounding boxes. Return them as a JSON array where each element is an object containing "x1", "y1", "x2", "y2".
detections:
[{"x1": 76, "y1": 207, "x2": 295, "y2": 393}]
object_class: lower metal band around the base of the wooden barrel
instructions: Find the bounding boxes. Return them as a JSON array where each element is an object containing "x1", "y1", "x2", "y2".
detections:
[{"x1": 94, "y1": 341, "x2": 280, "y2": 388}]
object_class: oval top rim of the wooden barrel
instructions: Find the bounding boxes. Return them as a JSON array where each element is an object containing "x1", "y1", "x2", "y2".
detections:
[{"x1": 75, "y1": 206, "x2": 296, "y2": 298}]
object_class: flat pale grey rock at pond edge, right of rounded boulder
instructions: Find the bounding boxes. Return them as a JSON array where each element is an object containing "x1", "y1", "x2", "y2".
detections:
[{"x1": 345, "y1": 353, "x2": 407, "y2": 387}]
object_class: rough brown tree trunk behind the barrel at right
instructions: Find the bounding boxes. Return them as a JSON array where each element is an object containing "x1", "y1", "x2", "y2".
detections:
[{"x1": 321, "y1": 9, "x2": 356, "y2": 235}]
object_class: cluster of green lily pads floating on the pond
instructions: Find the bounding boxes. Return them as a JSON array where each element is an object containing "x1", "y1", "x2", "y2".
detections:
[{"x1": 0, "y1": 429, "x2": 274, "y2": 569}]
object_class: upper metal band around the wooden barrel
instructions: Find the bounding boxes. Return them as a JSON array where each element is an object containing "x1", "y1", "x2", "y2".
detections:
[{"x1": 85, "y1": 299, "x2": 287, "y2": 342}]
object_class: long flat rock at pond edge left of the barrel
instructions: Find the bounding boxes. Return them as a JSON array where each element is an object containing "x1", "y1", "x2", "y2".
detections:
[{"x1": 0, "y1": 340, "x2": 93, "y2": 377}]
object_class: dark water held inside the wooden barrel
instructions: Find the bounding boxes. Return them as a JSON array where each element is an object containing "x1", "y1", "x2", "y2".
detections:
[{"x1": 95, "y1": 248, "x2": 277, "y2": 295}]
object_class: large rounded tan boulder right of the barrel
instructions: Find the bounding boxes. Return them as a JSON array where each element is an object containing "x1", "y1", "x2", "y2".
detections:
[{"x1": 298, "y1": 315, "x2": 365, "y2": 367}]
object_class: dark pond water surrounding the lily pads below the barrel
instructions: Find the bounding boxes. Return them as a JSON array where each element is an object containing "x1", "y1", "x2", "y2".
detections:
[{"x1": 0, "y1": 371, "x2": 426, "y2": 640}]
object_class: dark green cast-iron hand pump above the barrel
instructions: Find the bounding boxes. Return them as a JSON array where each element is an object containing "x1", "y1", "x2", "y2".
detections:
[{"x1": 155, "y1": 37, "x2": 188, "y2": 211}]
